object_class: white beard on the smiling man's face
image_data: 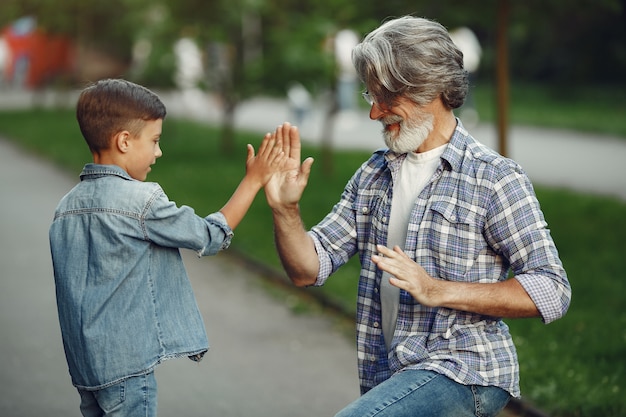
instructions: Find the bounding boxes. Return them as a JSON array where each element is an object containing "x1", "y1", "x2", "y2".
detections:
[{"x1": 381, "y1": 109, "x2": 434, "y2": 153}]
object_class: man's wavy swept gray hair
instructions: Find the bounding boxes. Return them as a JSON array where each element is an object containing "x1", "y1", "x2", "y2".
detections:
[{"x1": 352, "y1": 16, "x2": 469, "y2": 109}]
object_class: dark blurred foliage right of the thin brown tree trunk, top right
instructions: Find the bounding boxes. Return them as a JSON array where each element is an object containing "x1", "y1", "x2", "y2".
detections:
[{"x1": 504, "y1": 0, "x2": 626, "y2": 85}]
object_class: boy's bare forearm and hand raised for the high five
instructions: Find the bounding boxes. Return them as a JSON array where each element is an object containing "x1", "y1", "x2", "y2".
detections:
[{"x1": 220, "y1": 133, "x2": 286, "y2": 230}]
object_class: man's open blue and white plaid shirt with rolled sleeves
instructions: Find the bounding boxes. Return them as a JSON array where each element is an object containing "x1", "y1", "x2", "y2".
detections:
[{"x1": 309, "y1": 122, "x2": 571, "y2": 397}]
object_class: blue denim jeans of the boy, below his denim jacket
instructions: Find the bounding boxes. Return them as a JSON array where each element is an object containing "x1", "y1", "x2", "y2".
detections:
[{"x1": 78, "y1": 372, "x2": 157, "y2": 417}]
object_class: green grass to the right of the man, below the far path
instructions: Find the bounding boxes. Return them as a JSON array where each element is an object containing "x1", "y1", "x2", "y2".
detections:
[{"x1": 509, "y1": 188, "x2": 626, "y2": 416}]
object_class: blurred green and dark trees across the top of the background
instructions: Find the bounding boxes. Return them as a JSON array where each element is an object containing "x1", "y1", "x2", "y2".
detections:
[{"x1": 0, "y1": 0, "x2": 626, "y2": 92}]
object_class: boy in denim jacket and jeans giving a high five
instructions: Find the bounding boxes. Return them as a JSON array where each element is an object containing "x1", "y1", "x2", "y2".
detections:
[{"x1": 49, "y1": 79, "x2": 285, "y2": 416}]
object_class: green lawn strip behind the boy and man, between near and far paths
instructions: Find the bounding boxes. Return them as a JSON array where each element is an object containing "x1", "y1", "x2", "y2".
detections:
[{"x1": 0, "y1": 102, "x2": 626, "y2": 417}]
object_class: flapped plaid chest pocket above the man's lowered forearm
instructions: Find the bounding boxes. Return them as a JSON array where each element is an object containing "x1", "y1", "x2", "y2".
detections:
[{"x1": 417, "y1": 201, "x2": 487, "y2": 281}]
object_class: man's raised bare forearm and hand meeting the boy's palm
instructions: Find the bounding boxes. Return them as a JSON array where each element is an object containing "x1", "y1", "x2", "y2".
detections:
[{"x1": 265, "y1": 123, "x2": 319, "y2": 286}]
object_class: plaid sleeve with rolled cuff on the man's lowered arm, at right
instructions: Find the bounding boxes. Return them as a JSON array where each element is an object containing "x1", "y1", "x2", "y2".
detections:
[{"x1": 485, "y1": 168, "x2": 571, "y2": 323}]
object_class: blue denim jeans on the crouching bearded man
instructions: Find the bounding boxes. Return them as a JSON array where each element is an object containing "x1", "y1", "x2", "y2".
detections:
[{"x1": 335, "y1": 370, "x2": 510, "y2": 417}]
